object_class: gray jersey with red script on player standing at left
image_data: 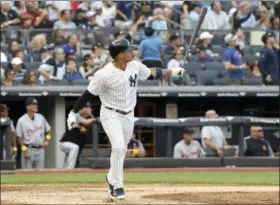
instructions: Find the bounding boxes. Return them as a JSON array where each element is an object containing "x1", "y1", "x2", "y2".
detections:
[{"x1": 16, "y1": 113, "x2": 51, "y2": 146}]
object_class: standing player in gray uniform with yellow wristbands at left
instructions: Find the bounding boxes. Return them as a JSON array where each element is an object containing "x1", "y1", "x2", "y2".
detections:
[{"x1": 16, "y1": 98, "x2": 51, "y2": 169}]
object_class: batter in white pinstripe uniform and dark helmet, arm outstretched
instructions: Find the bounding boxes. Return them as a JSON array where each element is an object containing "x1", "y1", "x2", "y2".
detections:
[{"x1": 67, "y1": 39, "x2": 185, "y2": 200}]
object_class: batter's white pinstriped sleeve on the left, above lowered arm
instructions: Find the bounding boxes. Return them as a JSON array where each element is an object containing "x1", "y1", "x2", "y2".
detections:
[{"x1": 87, "y1": 70, "x2": 105, "y2": 95}]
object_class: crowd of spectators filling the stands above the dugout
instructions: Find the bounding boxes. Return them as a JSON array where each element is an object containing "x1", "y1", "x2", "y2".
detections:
[{"x1": 0, "y1": 0, "x2": 280, "y2": 86}]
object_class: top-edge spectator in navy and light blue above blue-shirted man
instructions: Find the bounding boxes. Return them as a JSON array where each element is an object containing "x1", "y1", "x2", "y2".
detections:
[{"x1": 232, "y1": 1, "x2": 256, "y2": 30}]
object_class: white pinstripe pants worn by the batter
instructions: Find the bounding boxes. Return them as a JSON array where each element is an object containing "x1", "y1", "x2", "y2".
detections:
[{"x1": 100, "y1": 106, "x2": 134, "y2": 189}]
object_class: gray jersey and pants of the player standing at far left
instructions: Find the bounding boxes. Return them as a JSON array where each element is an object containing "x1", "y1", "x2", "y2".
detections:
[{"x1": 16, "y1": 113, "x2": 51, "y2": 169}]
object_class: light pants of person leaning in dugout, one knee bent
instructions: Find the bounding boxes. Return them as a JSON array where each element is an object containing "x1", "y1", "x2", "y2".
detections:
[{"x1": 59, "y1": 142, "x2": 79, "y2": 169}]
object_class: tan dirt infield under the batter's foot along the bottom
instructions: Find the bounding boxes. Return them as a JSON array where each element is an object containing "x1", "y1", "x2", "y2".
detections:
[{"x1": 1, "y1": 184, "x2": 279, "y2": 205}]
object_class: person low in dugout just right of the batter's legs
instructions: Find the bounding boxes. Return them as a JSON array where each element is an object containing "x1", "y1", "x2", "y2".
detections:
[{"x1": 126, "y1": 133, "x2": 146, "y2": 158}]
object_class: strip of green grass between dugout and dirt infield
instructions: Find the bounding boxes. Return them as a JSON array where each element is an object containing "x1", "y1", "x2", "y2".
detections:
[{"x1": 1, "y1": 172, "x2": 279, "y2": 185}]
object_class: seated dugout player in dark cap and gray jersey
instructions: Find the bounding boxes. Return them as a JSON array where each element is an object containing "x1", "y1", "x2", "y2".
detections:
[{"x1": 173, "y1": 127, "x2": 205, "y2": 159}]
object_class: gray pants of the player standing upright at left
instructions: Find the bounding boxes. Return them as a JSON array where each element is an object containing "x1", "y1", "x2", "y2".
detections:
[{"x1": 21, "y1": 148, "x2": 45, "y2": 169}]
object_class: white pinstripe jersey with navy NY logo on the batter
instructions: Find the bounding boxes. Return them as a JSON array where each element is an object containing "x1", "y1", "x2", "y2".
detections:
[{"x1": 87, "y1": 61, "x2": 151, "y2": 112}]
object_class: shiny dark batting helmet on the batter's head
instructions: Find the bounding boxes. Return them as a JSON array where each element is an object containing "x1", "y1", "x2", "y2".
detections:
[{"x1": 109, "y1": 38, "x2": 137, "y2": 59}]
